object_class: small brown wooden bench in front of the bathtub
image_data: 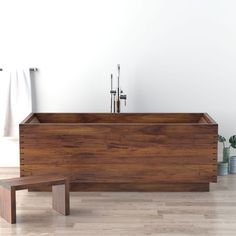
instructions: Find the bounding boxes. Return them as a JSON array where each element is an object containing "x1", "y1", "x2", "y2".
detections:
[{"x1": 0, "y1": 176, "x2": 70, "y2": 224}]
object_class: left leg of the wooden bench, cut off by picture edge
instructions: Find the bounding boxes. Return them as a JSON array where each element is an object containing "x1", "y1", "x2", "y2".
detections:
[{"x1": 0, "y1": 186, "x2": 16, "y2": 224}]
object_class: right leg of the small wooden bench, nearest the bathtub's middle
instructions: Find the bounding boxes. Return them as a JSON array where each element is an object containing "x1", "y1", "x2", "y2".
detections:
[{"x1": 52, "y1": 182, "x2": 70, "y2": 215}]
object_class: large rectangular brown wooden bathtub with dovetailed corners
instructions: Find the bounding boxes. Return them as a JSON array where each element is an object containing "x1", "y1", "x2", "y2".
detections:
[{"x1": 20, "y1": 113, "x2": 218, "y2": 191}]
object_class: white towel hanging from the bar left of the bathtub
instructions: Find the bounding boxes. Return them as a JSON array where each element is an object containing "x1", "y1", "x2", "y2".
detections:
[{"x1": 0, "y1": 68, "x2": 32, "y2": 138}]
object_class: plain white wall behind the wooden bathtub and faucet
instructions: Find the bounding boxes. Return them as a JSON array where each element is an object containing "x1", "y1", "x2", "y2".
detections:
[{"x1": 0, "y1": 0, "x2": 236, "y2": 165}]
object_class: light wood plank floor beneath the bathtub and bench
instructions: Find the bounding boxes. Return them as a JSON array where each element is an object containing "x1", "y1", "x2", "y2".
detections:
[{"x1": 0, "y1": 168, "x2": 236, "y2": 236}]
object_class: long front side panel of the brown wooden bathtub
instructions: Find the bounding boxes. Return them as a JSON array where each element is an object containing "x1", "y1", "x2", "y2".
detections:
[{"x1": 20, "y1": 124, "x2": 217, "y2": 190}]
